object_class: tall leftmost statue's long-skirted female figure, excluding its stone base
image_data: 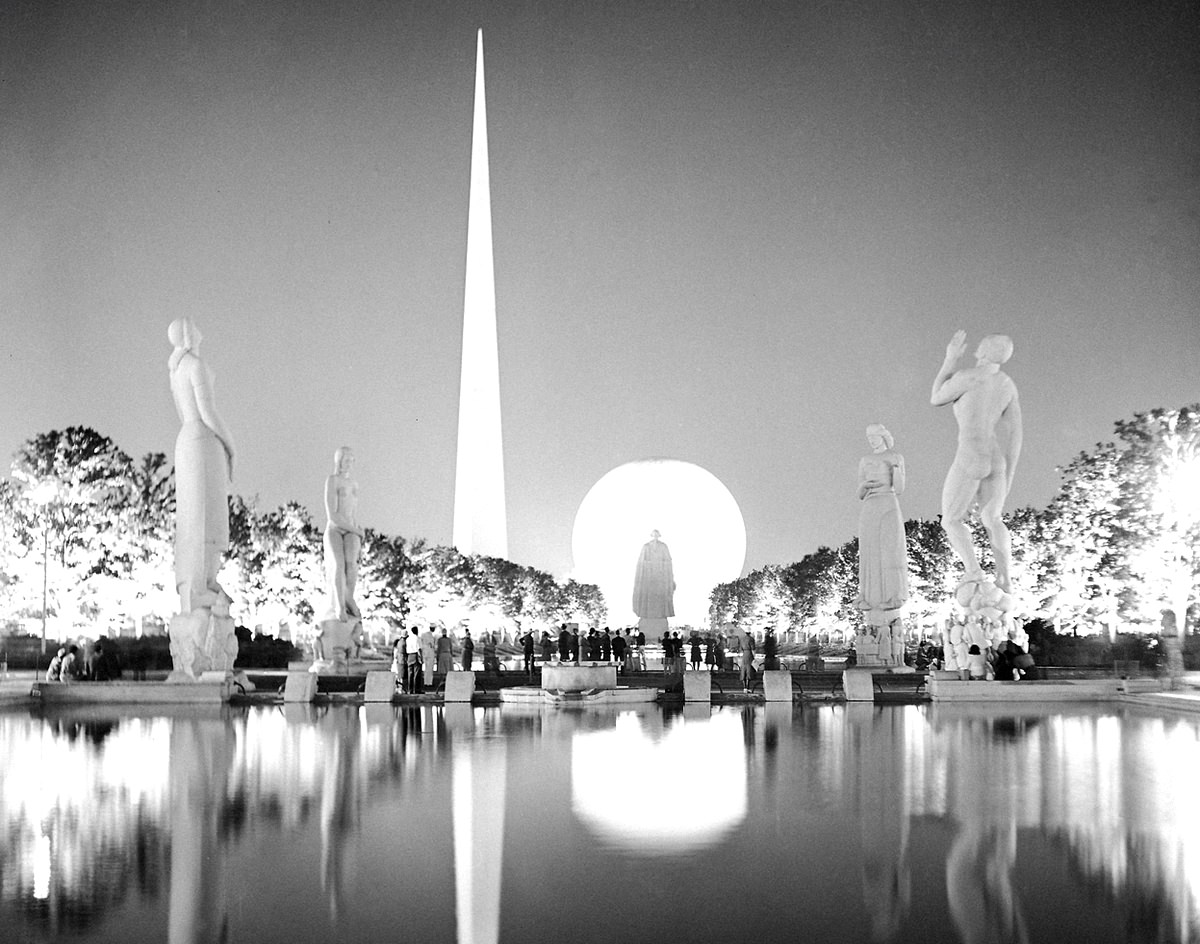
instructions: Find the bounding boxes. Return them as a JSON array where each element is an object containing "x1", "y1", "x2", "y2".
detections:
[{"x1": 167, "y1": 318, "x2": 234, "y2": 613}]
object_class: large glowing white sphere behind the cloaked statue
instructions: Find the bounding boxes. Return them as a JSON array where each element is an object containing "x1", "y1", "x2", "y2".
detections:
[{"x1": 571, "y1": 459, "x2": 746, "y2": 626}]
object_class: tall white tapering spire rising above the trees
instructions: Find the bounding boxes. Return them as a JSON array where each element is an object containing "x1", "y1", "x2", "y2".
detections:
[{"x1": 454, "y1": 30, "x2": 509, "y2": 558}]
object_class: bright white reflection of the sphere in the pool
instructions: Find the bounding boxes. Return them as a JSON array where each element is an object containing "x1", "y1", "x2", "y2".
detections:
[{"x1": 571, "y1": 712, "x2": 746, "y2": 855}]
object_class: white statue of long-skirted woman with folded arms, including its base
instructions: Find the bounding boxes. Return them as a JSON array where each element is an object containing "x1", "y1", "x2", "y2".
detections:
[{"x1": 856, "y1": 423, "x2": 908, "y2": 665}]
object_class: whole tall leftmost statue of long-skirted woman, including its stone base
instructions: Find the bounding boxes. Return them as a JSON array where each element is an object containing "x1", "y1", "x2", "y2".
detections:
[{"x1": 167, "y1": 318, "x2": 238, "y2": 679}]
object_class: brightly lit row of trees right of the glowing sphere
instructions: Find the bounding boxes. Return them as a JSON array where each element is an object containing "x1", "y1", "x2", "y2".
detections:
[{"x1": 709, "y1": 404, "x2": 1200, "y2": 633}]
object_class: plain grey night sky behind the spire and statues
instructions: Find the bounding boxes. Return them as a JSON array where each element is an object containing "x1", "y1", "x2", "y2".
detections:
[{"x1": 0, "y1": 0, "x2": 1200, "y2": 577}]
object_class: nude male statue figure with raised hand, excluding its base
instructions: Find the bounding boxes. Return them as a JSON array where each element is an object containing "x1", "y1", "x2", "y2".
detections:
[{"x1": 929, "y1": 331, "x2": 1021, "y2": 591}]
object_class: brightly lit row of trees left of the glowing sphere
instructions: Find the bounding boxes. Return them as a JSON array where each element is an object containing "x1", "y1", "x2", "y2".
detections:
[{"x1": 0, "y1": 427, "x2": 606, "y2": 642}]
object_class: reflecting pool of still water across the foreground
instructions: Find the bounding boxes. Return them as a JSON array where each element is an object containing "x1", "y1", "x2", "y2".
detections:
[{"x1": 0, "y1": 704, "x2": 1200, "y2": 944}]
